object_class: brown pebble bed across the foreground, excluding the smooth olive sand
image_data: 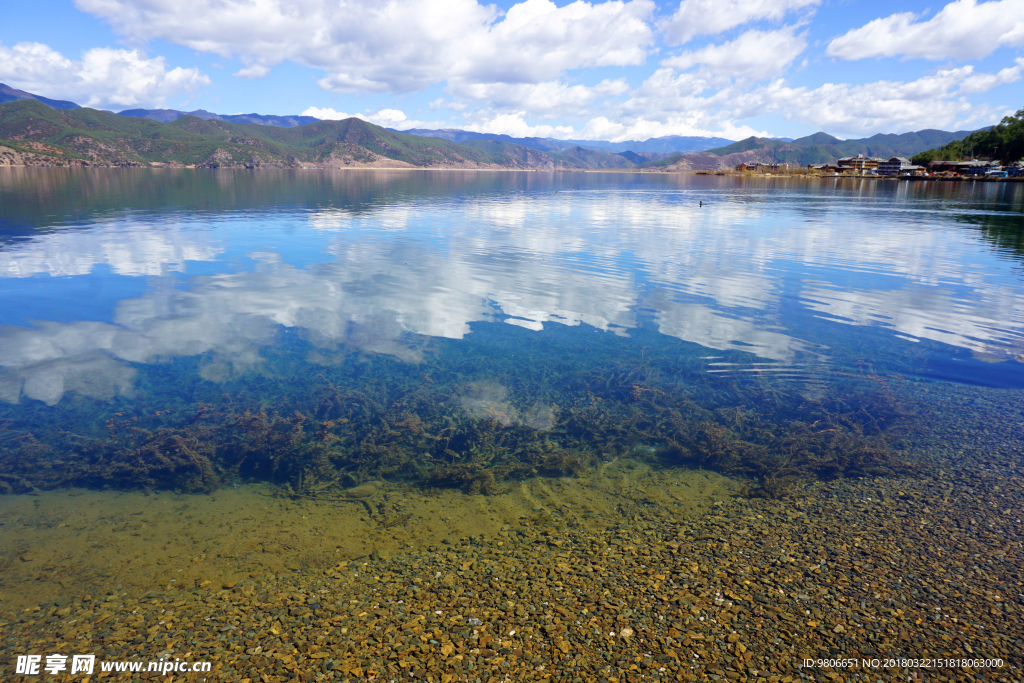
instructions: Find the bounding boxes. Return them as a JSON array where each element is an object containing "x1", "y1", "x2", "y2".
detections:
[{"x1": 0, "y1": 470, "x2": 1024, "y2": 683}]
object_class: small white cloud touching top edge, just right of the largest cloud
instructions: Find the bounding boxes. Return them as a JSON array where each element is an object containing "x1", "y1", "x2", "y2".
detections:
[{"x1": 662, "y1": 0, "x2": 820, "y2": 45}]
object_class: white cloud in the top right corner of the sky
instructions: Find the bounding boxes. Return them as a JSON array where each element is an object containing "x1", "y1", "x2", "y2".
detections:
[{"x1": 825, "y1": 0, "x2": 1024, "y2": 59}]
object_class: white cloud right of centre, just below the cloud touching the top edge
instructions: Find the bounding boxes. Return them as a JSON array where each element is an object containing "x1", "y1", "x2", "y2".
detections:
[{"x1": 662, "y1": 27, "x2": 807, "y2": 81}]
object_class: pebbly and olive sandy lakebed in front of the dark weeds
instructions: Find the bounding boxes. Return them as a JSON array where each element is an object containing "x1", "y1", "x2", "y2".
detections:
[{"x1": 0, "y1": 383, "x2": 1024, "y2": 683}]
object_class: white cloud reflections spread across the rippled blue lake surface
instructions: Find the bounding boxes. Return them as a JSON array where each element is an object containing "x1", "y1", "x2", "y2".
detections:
[{"x1": 0, "y1": 173, "x2": 1024, "y2": 403}]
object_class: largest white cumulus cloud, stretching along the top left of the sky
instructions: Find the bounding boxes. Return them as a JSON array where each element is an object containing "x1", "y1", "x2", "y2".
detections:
[{"x1": 76, "y1": 0, "x2": 654, "y2": 92}]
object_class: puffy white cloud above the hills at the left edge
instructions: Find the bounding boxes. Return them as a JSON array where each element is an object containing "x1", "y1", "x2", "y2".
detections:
[{"x1": 0, "y1": 42, "x2": 210, "y2": 109}]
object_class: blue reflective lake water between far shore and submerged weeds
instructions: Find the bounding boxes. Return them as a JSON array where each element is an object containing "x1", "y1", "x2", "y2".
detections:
[{"x1": 0, "y1": 169, "x2": 1024, "y2": 493}]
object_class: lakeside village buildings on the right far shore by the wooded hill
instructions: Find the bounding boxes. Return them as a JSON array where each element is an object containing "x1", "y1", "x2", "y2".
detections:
[{"x1": 736, "y1": 155, "x2": 1024, "y2": 180}]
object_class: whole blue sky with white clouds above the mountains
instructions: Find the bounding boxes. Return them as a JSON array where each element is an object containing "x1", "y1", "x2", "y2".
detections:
[{"x1": 0, "y1": 0, "x2": 1024, "y2": 140}]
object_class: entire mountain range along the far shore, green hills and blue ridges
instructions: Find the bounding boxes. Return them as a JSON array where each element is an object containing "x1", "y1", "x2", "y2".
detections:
[{"x1": 0, "y1": 84, "x2": 991, "y2": 171}]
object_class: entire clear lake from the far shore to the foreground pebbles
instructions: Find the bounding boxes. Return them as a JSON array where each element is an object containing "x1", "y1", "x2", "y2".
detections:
[{"x1": 0, "y1": 169, "x2": 1024, "y2": 680}]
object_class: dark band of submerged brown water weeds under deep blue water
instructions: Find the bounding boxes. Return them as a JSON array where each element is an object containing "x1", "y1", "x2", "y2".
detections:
[{"x1": 0, "y1": 324, "x2": 911, "y2": 500}]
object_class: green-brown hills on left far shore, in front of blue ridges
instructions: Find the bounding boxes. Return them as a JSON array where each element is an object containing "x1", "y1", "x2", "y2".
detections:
[{"x1": 0, "y1": 99, "x2": 631, "y2": 168}]
